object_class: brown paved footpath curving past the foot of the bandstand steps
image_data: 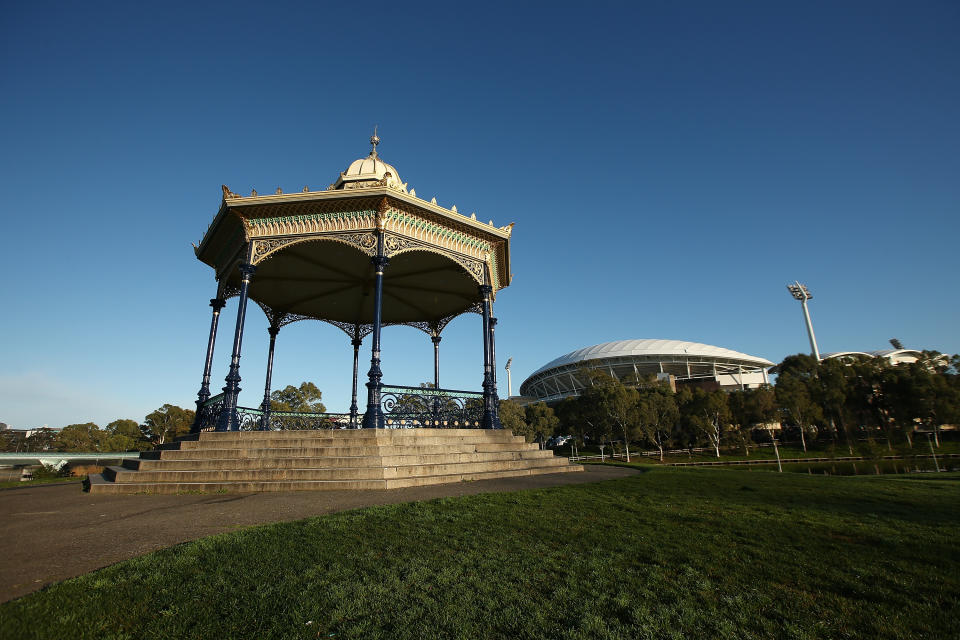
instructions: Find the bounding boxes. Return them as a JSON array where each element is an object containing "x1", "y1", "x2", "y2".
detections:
[{"x1": 0, "y1": 465, "x2": 637, "y2": 602}]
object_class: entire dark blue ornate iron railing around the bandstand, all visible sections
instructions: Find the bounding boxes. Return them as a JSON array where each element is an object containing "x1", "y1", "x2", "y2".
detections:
[{"x1": 195, "y1": 385, "x2": 483, "y2": 431}]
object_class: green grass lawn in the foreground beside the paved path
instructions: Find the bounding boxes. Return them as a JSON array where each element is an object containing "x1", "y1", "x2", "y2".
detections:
[{"x1": 0, "y1": 467, "x2": 960, "y2": 639}]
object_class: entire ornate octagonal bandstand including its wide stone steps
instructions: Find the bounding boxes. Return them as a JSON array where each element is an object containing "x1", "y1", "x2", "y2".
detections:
[{"x1": 89, "y1": 133, "x2": 583, "y2": 493}]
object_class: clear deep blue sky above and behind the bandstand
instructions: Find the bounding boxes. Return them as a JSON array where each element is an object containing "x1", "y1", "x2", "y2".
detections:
[{"x1": 0, "y1": 0, "x2": 960, "y2": 427}]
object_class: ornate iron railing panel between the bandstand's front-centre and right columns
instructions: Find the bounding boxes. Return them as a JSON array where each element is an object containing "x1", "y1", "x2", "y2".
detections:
[{"x1": 380, "y1": 385, "x2": 483, "y2": 429}]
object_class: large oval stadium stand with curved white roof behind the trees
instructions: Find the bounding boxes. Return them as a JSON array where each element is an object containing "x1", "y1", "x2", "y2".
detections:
[{"x1": 520, "y1": 340, "x2": 774, "y2": 403}]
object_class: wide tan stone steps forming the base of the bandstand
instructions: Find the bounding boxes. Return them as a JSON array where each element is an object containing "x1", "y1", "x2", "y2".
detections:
[{"x1": 90, "y1": 429, "x2": 583, "y2": 493}]
